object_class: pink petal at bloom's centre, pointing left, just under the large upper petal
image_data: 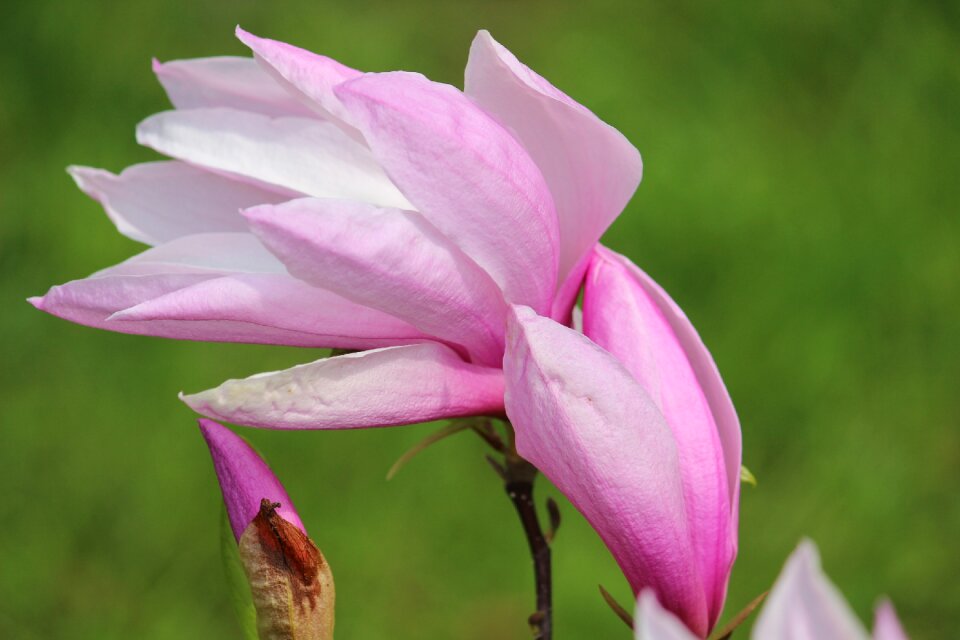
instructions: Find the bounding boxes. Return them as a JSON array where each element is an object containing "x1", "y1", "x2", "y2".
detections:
[{"x1": 245, "y1": 199, "x2": 506, "y2": 367}]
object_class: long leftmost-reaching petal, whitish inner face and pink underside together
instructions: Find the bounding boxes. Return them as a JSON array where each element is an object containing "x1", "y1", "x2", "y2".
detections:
[{"x1": 31, "y1": 234, "x2": 426, "y2": 349}]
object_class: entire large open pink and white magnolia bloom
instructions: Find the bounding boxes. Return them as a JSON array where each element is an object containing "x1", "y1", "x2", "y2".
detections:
[{"x1": 32, "y1": 31, "x2": 740, "y2": 636}]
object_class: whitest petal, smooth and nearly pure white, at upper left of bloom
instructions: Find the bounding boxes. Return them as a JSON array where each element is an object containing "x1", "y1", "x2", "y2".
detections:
[{"x1": 137, "y1": 109, "x2": 410, "y2": 208}]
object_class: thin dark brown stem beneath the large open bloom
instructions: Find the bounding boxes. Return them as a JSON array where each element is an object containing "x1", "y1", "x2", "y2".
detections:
[{"x1": 504, "y1": 451, "x2": 553, "y2": 640}]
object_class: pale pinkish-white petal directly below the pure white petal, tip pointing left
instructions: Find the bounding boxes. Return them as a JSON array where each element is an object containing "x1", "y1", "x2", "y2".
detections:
[{"x1": 68, "y1": 161, "x2": 288, "y2": 244}]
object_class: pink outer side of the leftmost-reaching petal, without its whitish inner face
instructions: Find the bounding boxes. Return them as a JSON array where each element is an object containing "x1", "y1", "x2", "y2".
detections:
[{"x1": 29, "y1": 274, "x2": 427, "y2": 349}]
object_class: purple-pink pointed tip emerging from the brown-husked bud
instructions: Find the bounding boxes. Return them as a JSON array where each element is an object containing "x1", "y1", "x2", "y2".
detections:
[{"x1": 194, "y1": 419, "x2": 306, "y2": 540}]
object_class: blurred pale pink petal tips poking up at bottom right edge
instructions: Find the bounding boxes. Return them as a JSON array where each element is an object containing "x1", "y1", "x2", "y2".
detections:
[{"x1": 634, "y1": 542, "x2": 907, "y2": 640}]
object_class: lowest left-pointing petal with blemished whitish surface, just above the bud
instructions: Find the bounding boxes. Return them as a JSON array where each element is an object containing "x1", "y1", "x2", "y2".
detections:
[{"x1": 181, "y1": 343, "x2": 503, "y2": 429}]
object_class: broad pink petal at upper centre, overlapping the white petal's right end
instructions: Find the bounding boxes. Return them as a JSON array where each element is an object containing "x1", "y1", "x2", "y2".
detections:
[{"x1": 335, "y1": 72, "x2": 558, "y2": 310}]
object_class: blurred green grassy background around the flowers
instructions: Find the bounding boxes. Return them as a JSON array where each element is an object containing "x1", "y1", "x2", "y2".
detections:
[{"x1": 0, "y1": 0, "x2": 960, "y2": 640}]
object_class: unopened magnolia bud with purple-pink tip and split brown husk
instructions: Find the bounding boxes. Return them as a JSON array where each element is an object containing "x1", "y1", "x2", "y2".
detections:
[{"x1": 200, "y1": 420, "x2": 335, "y2": 640}]
